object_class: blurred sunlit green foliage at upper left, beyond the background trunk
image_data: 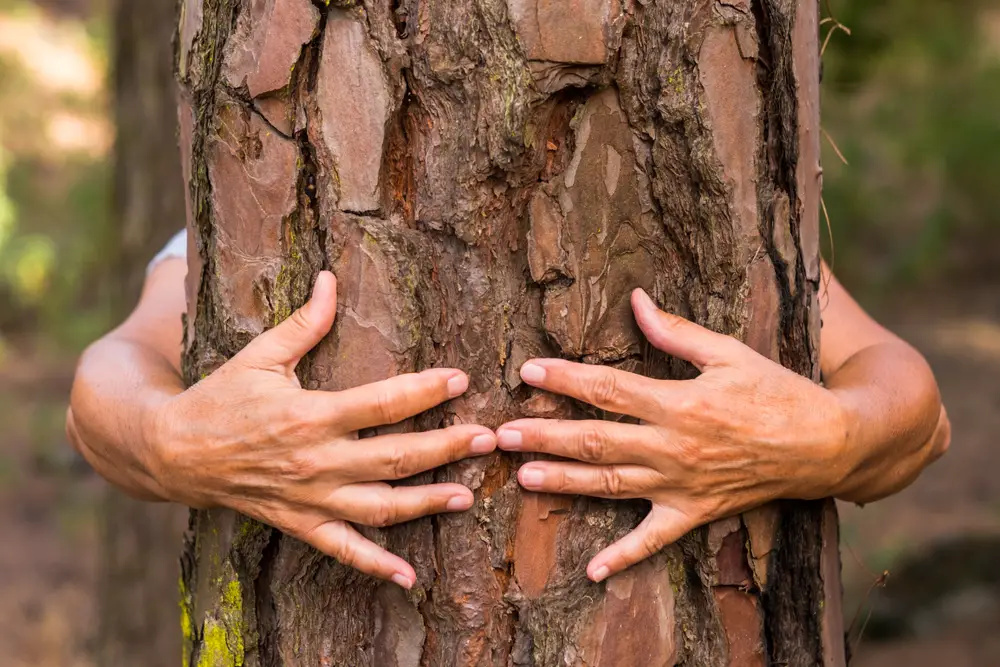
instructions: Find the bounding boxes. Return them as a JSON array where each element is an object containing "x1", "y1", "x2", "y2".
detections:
[{"x1": 0, "y1": 0, "x2": 112, "y2": 354}]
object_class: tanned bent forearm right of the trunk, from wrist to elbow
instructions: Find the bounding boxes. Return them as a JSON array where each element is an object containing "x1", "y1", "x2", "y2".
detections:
[{"x1": 826, "y1": 340, "x2": 950, "y2": 504}]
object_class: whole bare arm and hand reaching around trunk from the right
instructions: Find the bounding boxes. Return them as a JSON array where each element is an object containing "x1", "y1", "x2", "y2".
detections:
[{"x1": 498, "y1": 269, "x2": 950, "y2": 580}]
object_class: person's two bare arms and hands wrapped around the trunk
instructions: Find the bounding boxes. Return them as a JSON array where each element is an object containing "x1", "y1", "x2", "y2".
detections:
[{"x1": 67, "y1": 259, "x2": 950, "y2": 586}]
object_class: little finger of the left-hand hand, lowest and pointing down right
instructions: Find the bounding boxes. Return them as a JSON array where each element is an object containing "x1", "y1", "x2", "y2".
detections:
[{"x1": 302, "y1": 521, "x2": 417, "y2": 589}]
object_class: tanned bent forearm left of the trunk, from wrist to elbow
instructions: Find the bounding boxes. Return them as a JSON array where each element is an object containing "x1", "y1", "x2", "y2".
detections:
[{"x1": 66, "y1": 333, "x2": 184, "y2": 500}]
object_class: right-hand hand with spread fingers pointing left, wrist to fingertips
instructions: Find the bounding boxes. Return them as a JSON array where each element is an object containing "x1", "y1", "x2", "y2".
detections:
[{"x1": 497, "y1": 290, "x2": 847, "y2": 581}]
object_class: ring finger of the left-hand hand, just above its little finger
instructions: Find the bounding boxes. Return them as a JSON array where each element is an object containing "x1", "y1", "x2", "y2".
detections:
[{"x1": 324, "y1": 484, "x2": 474, "y2": 528}]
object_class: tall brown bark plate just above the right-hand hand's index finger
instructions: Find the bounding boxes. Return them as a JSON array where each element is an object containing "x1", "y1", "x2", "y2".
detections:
[{"x1": 528, "y1": 90, "x2": 662, "y2": 360}]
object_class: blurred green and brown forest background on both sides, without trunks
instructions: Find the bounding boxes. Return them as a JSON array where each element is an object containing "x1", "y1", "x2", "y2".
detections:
[{"x1": 0, "y1": 0, "x2": 1000, "y2": 667}]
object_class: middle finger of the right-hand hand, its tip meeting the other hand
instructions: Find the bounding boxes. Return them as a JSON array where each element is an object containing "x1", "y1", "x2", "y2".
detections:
[{"x1": 497, "y1": 419, "x2": 663, "y2": 467}]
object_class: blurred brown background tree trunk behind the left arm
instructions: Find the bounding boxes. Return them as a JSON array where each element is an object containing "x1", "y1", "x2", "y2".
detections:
[{"x1": 96, "y1": 0, "x2": 187, "y2": 667}]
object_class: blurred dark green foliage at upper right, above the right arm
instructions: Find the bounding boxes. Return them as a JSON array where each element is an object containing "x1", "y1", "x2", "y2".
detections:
[{"x1": 823, "y1": 0, "x2": 1000, "y2": 289}]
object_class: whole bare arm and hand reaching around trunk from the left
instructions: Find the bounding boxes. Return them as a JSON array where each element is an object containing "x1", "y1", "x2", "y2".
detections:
[{"x1": 67, "y1": 259, "x2": 495, "y2": 587}]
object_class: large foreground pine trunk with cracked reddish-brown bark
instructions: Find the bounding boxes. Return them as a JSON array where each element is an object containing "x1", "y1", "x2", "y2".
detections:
[{"x1": 178, "y1": 0, "x2": 844, "y2": 667}]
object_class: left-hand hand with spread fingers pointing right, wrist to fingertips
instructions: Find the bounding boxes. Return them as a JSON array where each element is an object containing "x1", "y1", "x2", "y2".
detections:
[{"x1": 151, "y1": 272, "x2": 496, "y2": 588}]
